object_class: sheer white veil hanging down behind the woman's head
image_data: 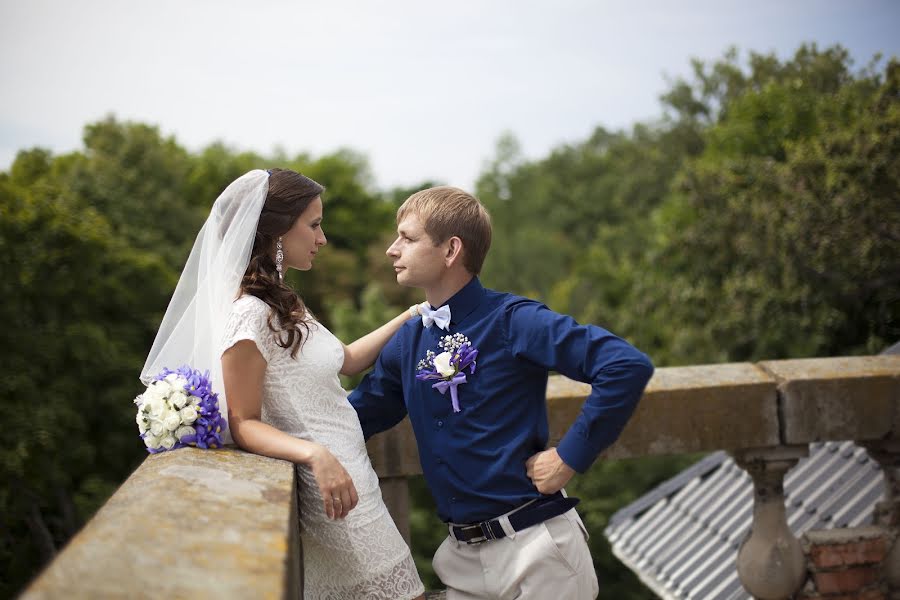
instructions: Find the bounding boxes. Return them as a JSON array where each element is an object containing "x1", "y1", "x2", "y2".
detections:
[{"x1": 141, "y1": 169, "x2": 269, "y2": 443}]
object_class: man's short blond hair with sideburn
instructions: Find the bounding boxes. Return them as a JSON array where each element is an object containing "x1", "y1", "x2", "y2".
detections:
[{"x1": 397, "y1": 185, "x2": 491, "y2": 275}]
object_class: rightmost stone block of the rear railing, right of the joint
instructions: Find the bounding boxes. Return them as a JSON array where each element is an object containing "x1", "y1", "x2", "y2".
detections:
[{"x1": 759, "y1": 355, "x2": 900, "y2": 444}]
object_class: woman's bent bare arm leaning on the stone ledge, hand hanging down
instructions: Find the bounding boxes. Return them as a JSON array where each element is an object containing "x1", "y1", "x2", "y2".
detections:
[{"x1": 222, "y1": 340, "x2": 359, "y2": 519}]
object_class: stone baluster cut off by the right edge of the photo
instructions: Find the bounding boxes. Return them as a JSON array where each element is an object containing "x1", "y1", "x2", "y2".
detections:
[{"x1": 863, "y1": 439, "x2": 900, "y2": 599}]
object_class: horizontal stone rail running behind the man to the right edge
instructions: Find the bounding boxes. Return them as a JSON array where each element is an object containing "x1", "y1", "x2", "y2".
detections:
[{"x1": 369, "y1": 355, "x2": 900, "y2": 477}]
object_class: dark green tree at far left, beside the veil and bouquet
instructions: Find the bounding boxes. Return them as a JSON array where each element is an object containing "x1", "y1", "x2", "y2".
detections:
[{"x1": 0, "y1": 168, "x2": 174, "y2": 596}]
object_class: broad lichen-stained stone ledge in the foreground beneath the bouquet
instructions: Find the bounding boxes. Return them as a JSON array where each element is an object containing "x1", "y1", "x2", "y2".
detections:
[{"x1": 22, "y1": 448, "x2": 299, "y2": 600}]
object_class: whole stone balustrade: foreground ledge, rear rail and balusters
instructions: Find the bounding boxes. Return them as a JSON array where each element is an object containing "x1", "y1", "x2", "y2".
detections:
[{"x1": 23, "y1": 355, "x2": 900, "y2": 599}]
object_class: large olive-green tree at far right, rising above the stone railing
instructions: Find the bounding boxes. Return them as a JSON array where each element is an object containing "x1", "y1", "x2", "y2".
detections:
[{"x1": 635, "y1": 50, "x2": 900, "y2": 363}]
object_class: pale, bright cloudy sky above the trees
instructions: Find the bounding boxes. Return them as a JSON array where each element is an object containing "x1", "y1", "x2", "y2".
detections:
[{"x1": 0, "y1": 0, "x2": 900, "y2": 188}]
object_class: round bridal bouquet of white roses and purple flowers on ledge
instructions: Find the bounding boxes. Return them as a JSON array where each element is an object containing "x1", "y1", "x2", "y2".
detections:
[{"x1": 134, "y1": 365, "x2": 228, "y2": 454}]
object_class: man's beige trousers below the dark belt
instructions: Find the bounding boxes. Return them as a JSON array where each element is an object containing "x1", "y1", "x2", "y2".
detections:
[{"x1": 432, "y1": 508, "x2": 600, "y2": 600}]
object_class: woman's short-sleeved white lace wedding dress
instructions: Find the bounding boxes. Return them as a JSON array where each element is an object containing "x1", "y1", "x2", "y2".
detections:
[{"x1": 222, "y1": 296, "x2": 424, "y2": 600}]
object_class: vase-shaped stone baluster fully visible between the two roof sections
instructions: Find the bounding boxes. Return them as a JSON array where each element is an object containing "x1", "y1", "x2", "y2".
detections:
[{"x1": 734, "y1": 445, "x2": 809, "y2": 600}]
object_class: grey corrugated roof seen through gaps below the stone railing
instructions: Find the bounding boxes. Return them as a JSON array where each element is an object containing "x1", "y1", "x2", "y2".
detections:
[{"x1": 604, "y1": 442, "x2": 884, "y2": 600}]
